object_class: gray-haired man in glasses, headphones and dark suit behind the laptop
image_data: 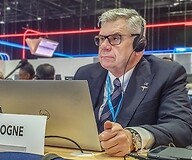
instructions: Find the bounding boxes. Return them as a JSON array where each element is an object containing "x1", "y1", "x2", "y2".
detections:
[{"x1": 74, "y1": 8, "x2": 192, "y2": 156}]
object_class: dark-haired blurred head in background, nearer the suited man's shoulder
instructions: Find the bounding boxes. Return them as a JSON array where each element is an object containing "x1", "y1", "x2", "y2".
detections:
[{"x1": 35, "y1": 63, "x2": 55, "y2": 80}]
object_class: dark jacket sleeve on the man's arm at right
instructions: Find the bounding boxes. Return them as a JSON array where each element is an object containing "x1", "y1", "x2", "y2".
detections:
[{"x1": 141, "y1": 65, "x2": 192, "y2": 147}]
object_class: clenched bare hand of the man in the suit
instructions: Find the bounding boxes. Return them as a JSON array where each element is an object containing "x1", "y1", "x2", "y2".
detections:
[{"x1": 99, "y1": 121, "x2": 133, "y2": 156}]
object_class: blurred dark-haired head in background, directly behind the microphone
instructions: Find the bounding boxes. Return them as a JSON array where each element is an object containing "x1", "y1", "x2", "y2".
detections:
[{"x1": 19, "y1": 62, "x2": 35, "y2": 80}]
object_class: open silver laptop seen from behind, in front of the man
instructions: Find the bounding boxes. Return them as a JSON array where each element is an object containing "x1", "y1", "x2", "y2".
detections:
[{"x1": 0, "y1": 80, "x2": 102, "y2": 151}]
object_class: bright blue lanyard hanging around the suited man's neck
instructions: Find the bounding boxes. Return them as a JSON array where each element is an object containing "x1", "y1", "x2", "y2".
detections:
[{"x1": 106, "y1": 75, "x2": 123, "y2": 122}]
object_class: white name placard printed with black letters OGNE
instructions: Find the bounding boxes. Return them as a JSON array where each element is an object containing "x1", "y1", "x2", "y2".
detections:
[{"x1": 0, "y1": 113, "x2": 47, "y2": 154}]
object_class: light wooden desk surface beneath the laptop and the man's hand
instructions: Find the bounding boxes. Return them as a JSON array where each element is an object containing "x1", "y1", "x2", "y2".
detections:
[{"x1": 45, "y1": 146, "x2": 135, "y2": 160}]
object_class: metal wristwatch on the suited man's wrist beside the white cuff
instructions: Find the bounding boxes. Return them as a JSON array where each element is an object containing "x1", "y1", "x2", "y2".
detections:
[{"x1": 128, "y1": 128, "x2": 142, "y2": 151}]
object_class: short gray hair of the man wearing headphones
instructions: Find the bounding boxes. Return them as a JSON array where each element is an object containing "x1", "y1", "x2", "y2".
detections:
[{"x1": 98, "y1": 8, "x2": 146, "y2": 34}]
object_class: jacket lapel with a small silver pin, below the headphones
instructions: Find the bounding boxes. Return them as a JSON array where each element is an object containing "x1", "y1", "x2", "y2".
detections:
[{"x1": 117, "y1": 58, "x2": 154, "y2": 127}]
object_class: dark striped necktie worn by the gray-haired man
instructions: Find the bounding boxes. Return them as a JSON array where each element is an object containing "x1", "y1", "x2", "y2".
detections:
[{"x1": 100, "y1": 78, "x2": 122, "y2": 124}]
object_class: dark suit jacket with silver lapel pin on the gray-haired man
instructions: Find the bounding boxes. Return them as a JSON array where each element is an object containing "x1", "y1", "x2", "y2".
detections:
[{"x1": 74, "y1": 56, "x2": 192, "y2": 147}]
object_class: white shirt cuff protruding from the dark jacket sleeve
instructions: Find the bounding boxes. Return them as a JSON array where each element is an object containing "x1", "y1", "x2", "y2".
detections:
[{"x1": 127, "y1": 127, "x2": 155, "y2": 150}]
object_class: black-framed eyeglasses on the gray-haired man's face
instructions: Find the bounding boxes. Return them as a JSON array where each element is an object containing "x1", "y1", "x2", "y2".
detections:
[{"x1": 95, "y1": 34, "x2": 136, "y2": 46}]
